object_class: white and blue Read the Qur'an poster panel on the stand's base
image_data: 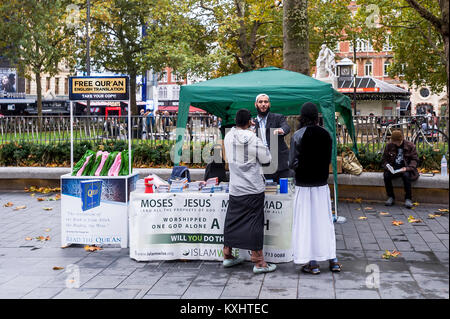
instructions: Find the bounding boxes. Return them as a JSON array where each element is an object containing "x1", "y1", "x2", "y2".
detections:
[{"x1": 61, "y1": 174, "x2": 138, "y2": 248}]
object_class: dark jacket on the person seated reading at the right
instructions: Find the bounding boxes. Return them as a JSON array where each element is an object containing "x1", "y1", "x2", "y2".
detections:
[{"x1": 383, "y1": 140, "x2": 419, "y2": 181}]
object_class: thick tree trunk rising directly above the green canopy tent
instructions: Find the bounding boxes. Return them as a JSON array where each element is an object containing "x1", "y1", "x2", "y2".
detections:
[{"x1": 283, "y1": 0, "x2": 309, "y2": 76}]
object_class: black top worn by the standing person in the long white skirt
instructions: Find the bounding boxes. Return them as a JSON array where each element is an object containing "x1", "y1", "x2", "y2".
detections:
[{"x1": 289, "y1": 125, "x2": 332, "y2": 187}]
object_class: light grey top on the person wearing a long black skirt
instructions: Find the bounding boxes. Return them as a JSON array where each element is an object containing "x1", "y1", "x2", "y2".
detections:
[{"x1": 224, "y1": 127, "x2": 272, "y2": 196}]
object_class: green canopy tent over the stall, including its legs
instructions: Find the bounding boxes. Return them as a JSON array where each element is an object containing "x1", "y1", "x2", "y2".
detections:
[{"x1": 174, "y1": 67, "x2": 356, "y2": 216}]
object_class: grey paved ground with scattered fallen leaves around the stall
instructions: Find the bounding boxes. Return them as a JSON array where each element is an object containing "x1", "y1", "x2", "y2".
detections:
[{"x1": 0, "y1": 192, "x2": 449, "y2": 299}]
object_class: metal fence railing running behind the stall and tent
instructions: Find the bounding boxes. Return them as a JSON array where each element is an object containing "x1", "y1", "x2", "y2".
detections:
[{"x1": 0, "y1": 115, "x2": 449, "y2": 152}]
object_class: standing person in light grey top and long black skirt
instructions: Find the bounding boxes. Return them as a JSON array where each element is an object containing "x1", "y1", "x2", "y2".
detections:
[{"x1": 223, "y1": 109, "x2": 276, "y2": 274}]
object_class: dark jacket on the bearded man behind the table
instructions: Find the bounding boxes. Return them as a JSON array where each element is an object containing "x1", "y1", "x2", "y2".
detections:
[{"x1": 255, "y1": 112, "x2": 291, "y2": 172}]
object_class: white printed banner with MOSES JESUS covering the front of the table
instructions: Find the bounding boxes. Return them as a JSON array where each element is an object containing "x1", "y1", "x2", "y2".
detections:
[{"x1": 129, "y1": 192, "x2": 293, "y2": 262}]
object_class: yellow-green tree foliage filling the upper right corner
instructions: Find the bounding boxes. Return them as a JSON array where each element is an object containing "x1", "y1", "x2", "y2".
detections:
[{"x1": 357, "y1": 0, "x2": 448, "y2": 93}]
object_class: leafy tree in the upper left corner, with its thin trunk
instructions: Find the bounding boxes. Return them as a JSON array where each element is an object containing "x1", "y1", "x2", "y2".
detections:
[{"x1": 0, "y1": 0, "x2": 76, "y2": 116}]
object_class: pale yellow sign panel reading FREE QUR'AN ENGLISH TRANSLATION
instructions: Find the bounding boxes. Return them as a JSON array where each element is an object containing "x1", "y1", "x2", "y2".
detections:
[{"x1": 72, "y1": 78, "x2": 127, "y2": 94}]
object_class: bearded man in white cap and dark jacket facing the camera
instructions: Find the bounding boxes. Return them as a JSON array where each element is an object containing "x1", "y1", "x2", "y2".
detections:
[{"x1": 255, "y1": 94, "x2": 292, "y2": 183}]
